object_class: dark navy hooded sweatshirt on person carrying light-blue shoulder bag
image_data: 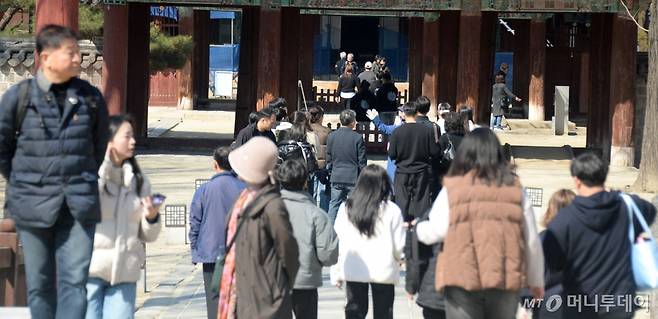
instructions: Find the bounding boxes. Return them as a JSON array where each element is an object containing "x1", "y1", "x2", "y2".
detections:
[{"x1": 543, "y1": 191, "x2": 656, "y2": 318}]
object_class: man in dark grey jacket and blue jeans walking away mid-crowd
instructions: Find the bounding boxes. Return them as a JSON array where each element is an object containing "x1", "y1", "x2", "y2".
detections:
[{"x1": 326, "y1": 110, "x2": 368, "y2": 224}]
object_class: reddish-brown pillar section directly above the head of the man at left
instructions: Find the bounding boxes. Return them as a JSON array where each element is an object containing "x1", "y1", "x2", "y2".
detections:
[{"x1": 36, "y1": 0, "x2": 80, "y2": 32}]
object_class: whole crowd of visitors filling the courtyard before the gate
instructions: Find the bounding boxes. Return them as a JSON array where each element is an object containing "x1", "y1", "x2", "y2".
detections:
[{"x1": 0, "y1": 25, "x2": 656, "y2": 319}]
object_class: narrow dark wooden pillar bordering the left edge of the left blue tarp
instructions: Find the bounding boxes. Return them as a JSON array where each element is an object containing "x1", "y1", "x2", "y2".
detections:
[{"x1": 192, "y1": 10, "x2": 210, "y2": 107}]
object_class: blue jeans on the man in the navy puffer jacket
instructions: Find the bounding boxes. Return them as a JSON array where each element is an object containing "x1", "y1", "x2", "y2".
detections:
[{"x1": 18, "y1": 205, "x2": 96, "y2": 319}]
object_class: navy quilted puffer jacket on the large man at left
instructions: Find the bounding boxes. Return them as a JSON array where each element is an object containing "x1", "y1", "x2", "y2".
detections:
[{"x1": 0, "y1": 71, "x2": 109, "y2": 227}]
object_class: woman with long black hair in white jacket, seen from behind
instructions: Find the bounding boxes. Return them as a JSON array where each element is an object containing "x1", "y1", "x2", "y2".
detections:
[{"x1": 331, "y1": 165, "x2": 405, "y2": 319}]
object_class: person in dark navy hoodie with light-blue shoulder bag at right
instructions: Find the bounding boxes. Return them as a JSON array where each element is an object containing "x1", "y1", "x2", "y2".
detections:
[{"x1": 543, "y1": 153, "x2": 656, "y2": 319}]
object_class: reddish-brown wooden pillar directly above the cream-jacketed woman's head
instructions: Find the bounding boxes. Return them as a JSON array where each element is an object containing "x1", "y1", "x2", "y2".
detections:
[{"x1": 101, "y1": 5, "x2": 128, "y2": 115}]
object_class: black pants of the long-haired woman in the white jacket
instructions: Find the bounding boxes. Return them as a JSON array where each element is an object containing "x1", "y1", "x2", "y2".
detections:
[{"x1": 345, "y1": 281, "x2": 395, "y2": 319}]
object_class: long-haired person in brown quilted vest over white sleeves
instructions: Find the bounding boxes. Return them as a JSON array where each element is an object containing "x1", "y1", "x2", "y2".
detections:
[{"x1": 416, "y1": 128, "x2": 544, "y2": 319}]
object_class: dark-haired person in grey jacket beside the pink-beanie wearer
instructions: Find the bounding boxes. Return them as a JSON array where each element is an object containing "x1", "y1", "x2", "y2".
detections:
[{"x1": 275, "y1": 159, "x2": 338, "y2": 319}]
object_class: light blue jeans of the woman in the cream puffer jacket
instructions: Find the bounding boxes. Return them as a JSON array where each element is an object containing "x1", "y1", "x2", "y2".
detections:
[{"x1": 86, "y1": 278, "x2": 137, "y2": 319}]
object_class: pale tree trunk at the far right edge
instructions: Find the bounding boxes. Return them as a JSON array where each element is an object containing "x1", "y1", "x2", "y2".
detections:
[{"x1": 633, "y1": 0, "x2": 658, "y2": 192}]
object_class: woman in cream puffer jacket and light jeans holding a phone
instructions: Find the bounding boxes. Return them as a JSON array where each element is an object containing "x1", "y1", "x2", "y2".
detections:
[{"x1": 86, "y1": 115, "x2": 162, "y2": 319}]
